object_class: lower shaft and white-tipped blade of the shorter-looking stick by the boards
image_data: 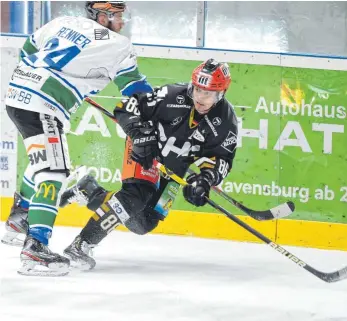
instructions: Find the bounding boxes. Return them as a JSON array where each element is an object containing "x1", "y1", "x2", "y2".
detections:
[{"x1": 188, "y1": 168, "x2": 295, "y2": 221}]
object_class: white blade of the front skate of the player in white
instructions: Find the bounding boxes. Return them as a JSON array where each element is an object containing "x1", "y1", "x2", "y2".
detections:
[{"x1": 17, "y1": 261, "x2": 70, "y2": 277}]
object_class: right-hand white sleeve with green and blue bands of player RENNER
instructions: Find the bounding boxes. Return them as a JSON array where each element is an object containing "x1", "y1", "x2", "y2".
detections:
[{"x1": 112, "y1": 39, "x2": 153, "y2": 97}]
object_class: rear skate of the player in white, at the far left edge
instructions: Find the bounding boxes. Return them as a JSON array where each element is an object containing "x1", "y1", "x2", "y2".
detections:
[{"x1": 1, "y1": 193, "x2": 28, "y2": 246}]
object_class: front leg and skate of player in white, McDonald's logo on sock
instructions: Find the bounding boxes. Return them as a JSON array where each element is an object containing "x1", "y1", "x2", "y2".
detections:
[{"x1": 7, "y1": 106, "x2": 70, "y2": 275}]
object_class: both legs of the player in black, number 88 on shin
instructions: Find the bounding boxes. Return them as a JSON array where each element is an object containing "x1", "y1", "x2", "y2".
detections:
[{"x1": 63, "y1": 176, "x2": 179, "y2": 269}]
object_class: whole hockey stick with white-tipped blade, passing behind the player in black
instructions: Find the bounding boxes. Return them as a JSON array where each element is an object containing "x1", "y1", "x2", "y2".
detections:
[{"x1": 85, "y1": 97, "x2": 295, "y2": 221}]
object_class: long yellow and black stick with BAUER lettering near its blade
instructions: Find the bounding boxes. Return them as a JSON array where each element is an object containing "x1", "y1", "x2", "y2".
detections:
[{"x1": 156, "y1": 162, "x2": 347, "y2": 283}]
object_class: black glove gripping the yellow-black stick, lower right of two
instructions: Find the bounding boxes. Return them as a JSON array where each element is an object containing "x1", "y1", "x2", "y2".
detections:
[{"x1": 183, "y1": 169, "x2": 219, "y2": 206}]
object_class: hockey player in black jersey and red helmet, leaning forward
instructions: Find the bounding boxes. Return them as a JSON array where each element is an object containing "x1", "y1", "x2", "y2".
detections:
[{"x1": 62, "y1": 59, "x2": 237, "y2": 269}]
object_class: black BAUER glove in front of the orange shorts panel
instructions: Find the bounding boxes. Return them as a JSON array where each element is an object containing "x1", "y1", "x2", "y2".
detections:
[{"x1": 129, "y1": 121, "x2": 160, "y2": 170}]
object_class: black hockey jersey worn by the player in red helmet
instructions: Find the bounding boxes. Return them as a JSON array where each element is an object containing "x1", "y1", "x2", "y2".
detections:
[{"x1": 114, "y1": 84, "x2": 237, "y2": 179}]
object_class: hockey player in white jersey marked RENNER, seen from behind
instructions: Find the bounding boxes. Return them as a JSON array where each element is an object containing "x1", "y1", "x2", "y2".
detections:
[{"x1": 2, "y1": 1, "x2": 152, "y2": 275}]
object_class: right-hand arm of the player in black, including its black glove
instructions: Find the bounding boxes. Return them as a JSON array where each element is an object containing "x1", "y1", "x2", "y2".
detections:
[{"x1": 183, "y1": 119, "x2": 237, "y2": 206}]
